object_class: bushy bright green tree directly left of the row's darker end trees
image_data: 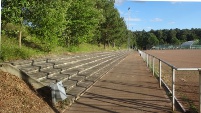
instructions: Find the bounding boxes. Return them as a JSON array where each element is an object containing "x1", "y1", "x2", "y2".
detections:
[{"x1": 65, "y1": 0, "x2": 103, "y2": 45}]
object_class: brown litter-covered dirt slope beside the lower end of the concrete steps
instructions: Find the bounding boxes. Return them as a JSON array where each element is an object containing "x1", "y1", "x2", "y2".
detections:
[{"x1": 0, "y1": 71, "x2": 54, "y2": 113}]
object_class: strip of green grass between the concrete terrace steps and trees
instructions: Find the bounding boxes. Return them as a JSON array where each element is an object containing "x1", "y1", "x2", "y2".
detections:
[{"x1": 0, "y1": 36, "x2": 121, "y2": 62}]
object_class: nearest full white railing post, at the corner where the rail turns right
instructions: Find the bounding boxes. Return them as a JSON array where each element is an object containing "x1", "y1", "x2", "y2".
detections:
[{"x1": 172, "y1": 67, "x2": 175, "y2": 111}]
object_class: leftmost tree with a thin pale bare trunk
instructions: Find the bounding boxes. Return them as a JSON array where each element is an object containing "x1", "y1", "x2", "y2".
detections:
[{"x1": 2, "y1": 0, "x2": 30, "y2": 48}]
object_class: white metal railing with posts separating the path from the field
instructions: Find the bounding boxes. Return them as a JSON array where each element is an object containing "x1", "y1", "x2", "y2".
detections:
[{"x1": 138, "y1": 50, "x2": 201, "y2": 113}]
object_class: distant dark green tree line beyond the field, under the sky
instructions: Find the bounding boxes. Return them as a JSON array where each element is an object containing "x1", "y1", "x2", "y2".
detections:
[{"x1": 131, "y1": 28, "x2": 201, "y2": 49}]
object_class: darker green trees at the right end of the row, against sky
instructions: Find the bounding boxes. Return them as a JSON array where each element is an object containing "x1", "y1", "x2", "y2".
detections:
[{"x1": 101, "y1": 0, "x2": 128, "y2": 48}]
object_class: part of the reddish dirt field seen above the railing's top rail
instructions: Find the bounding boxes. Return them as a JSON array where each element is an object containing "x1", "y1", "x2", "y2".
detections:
[{"x1": 145, "y1": 50, "x2": 201, "y2": 68}]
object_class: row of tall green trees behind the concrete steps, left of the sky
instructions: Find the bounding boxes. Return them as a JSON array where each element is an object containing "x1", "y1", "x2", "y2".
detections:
[{"x1": 1, "y1": 0, "x2": 128, "y2": 51}]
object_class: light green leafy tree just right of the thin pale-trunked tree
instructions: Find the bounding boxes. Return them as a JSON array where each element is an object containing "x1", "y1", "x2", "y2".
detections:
[{"x1": 27, "y1": 0, "x2": 71, "y2": 51}]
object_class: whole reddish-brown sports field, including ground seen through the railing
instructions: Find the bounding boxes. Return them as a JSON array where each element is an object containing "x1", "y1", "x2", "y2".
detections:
[{"x1": 145, "y1": 50, "x2": 201, "y2": 112}]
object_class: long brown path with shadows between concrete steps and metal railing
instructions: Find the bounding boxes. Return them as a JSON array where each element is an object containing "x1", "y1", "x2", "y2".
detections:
[{"x1": 64, "y1": 52, "x2": 181, "y2": 113}]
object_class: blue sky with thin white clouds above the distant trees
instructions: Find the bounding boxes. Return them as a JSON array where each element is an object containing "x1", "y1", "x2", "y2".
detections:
[{"x1": 115, "y1": 0, "x2": 201, "y2": 31}]
